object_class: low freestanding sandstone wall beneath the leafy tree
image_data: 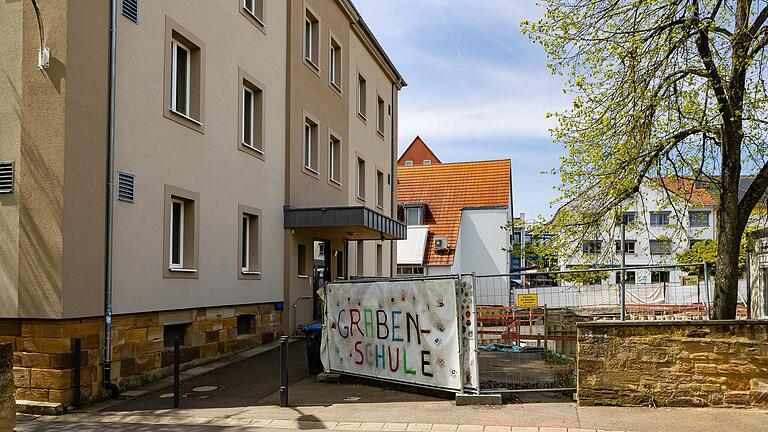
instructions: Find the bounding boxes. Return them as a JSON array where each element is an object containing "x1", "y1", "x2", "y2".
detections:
[{"x1": 577, "y1": 320, "x2": 768, "y2": 408}]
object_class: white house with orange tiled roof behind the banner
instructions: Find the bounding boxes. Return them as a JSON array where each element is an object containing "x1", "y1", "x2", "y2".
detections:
[{"x1": 397, "y1": 137, "x2": 512, "y2": 275}]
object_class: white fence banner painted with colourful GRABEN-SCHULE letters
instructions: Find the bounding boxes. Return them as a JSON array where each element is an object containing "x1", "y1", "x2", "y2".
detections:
[{"x1": 321, "y1": 279, "x2": 462, "y2": 390}]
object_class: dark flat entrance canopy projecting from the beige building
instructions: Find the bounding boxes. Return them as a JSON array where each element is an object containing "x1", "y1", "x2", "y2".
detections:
[{"x1": 283, "y1": 206, "x2": 406, "y2": 240}]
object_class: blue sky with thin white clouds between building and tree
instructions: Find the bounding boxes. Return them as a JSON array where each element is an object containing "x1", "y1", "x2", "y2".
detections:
[{"x1": 355, "y1": 0, "x2": 569, "y2": 218}]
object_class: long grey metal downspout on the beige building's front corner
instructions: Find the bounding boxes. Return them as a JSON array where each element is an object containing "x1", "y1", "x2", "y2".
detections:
[{"x1": 102, "y1": 0, "x2": 120, "y2": 398}]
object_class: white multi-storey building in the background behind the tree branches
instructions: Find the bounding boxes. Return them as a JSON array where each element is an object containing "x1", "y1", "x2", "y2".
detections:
[{"x1": 561, "y1": 179, "x2": 716, "y2": 284}]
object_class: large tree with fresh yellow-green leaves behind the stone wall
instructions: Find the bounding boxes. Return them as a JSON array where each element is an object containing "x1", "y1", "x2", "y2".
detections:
[{"x1": 522, "y1": 0, "x2": 768, "y2": 319}]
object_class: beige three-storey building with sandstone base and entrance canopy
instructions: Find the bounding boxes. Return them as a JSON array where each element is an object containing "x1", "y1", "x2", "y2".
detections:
[{"x1": 0, "y1": 0, "x2": 405, "y2": 405}]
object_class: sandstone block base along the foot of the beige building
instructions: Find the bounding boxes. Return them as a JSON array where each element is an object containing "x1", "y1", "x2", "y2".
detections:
[{"x1": 0, "y1": 304, "x2": 282, "y2": 406}]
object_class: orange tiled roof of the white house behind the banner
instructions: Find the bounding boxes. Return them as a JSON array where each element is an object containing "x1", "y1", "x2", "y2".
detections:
[{"x1": 397, "y1": 159, "x2": 511, "y2": 265}]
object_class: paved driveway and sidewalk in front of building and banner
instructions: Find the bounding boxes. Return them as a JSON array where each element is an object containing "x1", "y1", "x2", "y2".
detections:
[{"x1": 17, "y1": 344, "x2": 768, "y2": 432}]
